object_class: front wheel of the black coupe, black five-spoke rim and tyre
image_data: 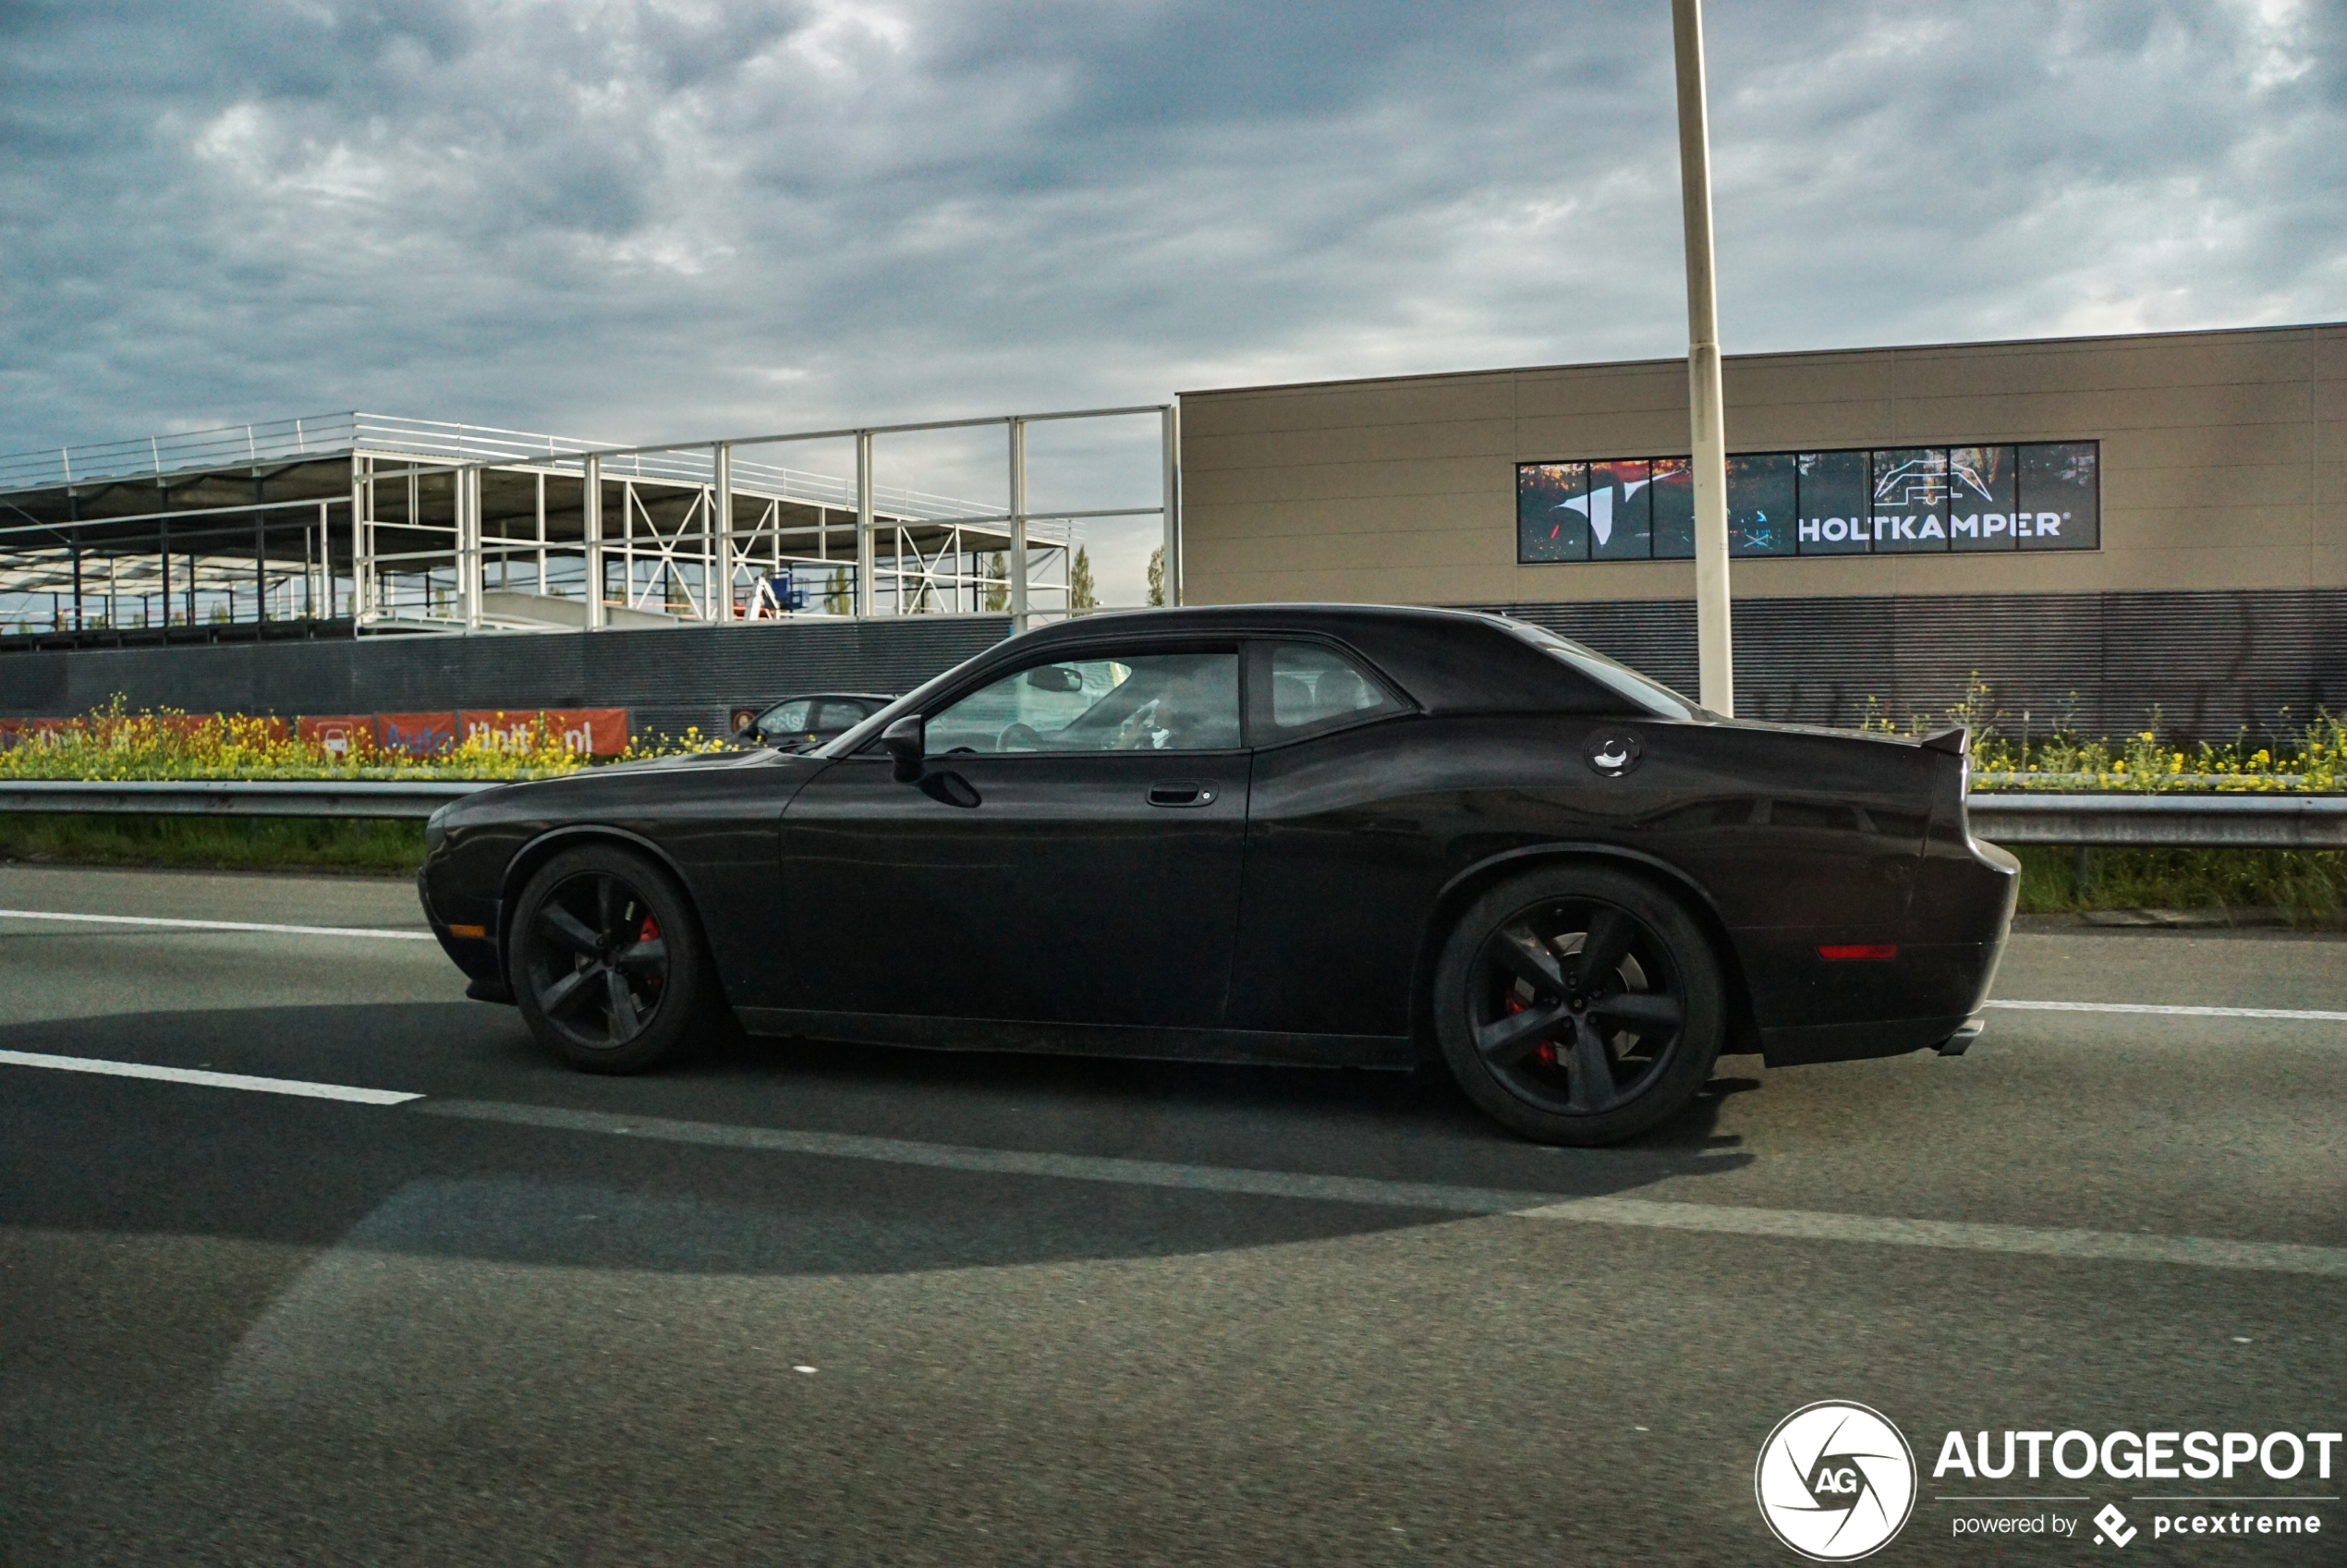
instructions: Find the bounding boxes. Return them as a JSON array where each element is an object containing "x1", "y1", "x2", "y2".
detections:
[{"x1": 507, "y1": 845, "x2": 725, "y2": 1073}]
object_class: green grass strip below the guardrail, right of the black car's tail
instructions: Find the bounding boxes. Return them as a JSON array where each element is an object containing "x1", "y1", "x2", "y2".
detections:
[{"x1": 2013, "y1": 845, "x2": 2347, "y2": 927}]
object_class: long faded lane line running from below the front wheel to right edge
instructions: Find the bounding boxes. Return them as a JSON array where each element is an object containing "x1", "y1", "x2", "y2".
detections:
[{"x1": 416, "y1": 1099, "x2": 2347, "y2": 1280}]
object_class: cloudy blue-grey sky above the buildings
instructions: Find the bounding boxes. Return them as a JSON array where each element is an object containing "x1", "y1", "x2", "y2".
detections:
[{"x1": 0, "y1": 0, "x2": 2347, "y2": 465}]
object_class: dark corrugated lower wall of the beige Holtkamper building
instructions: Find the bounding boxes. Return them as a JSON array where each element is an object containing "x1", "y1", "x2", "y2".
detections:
[{"x1": 1483, "y1": 590, "x2": 2347, "y2": 742}]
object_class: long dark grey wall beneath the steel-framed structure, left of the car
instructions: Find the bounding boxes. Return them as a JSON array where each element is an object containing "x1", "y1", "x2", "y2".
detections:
[{"x1": 0, "y1": 615, "x2": 1009, "y2": 735}]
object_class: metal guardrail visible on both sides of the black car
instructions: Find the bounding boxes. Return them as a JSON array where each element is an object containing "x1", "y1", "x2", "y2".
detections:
[{"x1": 0, "y1": 779, "x2": 2347, "y2": 850}]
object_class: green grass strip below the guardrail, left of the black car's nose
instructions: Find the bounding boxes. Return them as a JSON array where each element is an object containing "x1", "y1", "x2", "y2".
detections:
[{"x1": 0, "y1": 812, "x2": 425, "y2": 876}]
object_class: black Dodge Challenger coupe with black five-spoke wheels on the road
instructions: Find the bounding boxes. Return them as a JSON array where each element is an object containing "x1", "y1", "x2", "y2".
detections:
[{"x1": 418, "y1": 605, "x2": 2018, "y2": 1143}]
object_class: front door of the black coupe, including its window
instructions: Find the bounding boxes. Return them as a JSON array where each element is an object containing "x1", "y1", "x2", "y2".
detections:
[{"x1": 779, "y1": 643, "x2": 1248, "y2": 1033}]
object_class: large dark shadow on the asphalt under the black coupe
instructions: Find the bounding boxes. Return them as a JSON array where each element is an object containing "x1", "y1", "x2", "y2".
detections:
[{"x1": 0, "y1": 1003, "x2": 1756, "y2": 1289}]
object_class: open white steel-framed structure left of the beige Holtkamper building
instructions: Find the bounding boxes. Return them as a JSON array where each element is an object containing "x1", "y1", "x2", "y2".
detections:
[{"x1": 0, "y1": 406, "x2": 1181, "y2": 646}]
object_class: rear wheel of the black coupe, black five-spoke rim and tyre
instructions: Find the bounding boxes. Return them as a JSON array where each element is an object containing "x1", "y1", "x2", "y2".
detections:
[{"x1": 1434, "y1": 864, "x2": 1727, "y2": 1146}]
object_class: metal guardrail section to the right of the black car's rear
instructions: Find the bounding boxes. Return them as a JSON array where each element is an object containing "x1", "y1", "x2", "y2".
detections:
[{"x1": 1967, "y1": 794, "x2": 2347, "y2": 850}]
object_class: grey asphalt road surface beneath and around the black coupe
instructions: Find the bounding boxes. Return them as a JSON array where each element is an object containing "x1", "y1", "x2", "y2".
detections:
[{"x1": 0, "y1": 866, "x2": 2347, "y2": 1565}]
